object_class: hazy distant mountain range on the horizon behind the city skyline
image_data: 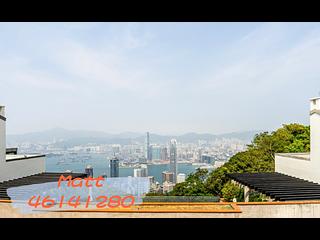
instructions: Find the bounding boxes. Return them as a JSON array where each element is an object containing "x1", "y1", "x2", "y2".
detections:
[{"x1": 7, "y1": 128, "x2": 260, "y2": 147}]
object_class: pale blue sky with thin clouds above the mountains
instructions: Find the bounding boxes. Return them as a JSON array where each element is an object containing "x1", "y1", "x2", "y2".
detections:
[{"x1": 0, "y1": 23, "x2": 320, "y2": 134}]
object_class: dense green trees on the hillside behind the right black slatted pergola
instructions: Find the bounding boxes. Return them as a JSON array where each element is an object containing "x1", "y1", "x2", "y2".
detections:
[{"x1": 170, "y1": 123, "x2": 310, "y2": 196}]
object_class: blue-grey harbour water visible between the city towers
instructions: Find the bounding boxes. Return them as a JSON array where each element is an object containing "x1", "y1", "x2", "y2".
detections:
[{"x1": 46, "y1": 153, "x2": 199, "y2": 182}]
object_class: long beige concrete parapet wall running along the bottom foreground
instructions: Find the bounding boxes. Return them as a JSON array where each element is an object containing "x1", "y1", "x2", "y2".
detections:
[{"x1": 0, "y1": 202, "x2": 320, "y2": 218}]
